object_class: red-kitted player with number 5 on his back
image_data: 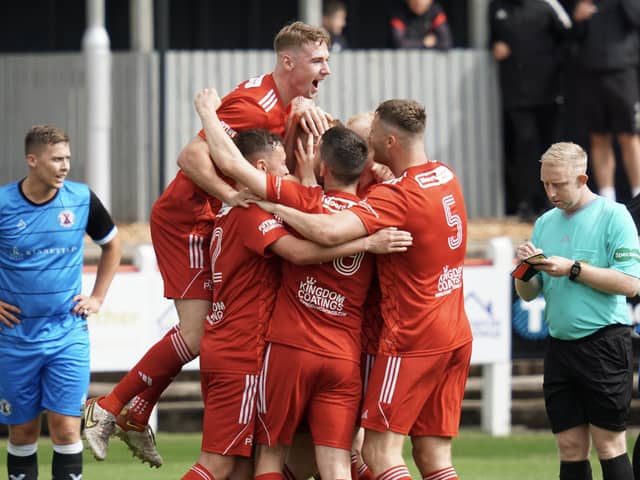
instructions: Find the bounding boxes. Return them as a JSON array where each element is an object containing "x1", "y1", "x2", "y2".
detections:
[{"x1": 242, "y1": 100, "x2": 472, "y2": 480}]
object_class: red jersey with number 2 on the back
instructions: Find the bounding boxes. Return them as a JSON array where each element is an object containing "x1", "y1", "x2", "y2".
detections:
[{"x1": 200, "y1": 205, "x2": 288, "y2": 374}]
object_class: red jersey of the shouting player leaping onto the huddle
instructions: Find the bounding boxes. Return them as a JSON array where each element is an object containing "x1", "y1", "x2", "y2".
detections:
[{"x1": 154, "y1": 74, "x2": 290, "y2": 227}]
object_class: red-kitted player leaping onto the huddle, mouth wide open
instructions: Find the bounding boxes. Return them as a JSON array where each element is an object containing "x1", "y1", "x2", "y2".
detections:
[{"x1": 85, "y1": 22, "x2": 331, "y2": 467}]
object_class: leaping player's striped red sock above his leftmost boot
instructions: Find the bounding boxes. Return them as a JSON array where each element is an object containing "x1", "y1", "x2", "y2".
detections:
[{"x1": 98, "y1": 327, "x2": 197, "y2": 416}]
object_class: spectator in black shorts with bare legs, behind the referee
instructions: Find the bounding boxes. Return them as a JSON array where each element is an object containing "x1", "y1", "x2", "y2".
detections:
[{"x1": 566, "y1": 0, "x2": 640, "y2": 199}]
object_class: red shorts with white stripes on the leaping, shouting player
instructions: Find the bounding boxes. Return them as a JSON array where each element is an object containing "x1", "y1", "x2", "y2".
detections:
[{"x1": 149, "y1": 209, "x2": 213, "y2": 300}]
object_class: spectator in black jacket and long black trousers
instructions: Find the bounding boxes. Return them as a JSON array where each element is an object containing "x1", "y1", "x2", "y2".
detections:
[{"x1": 489, "y1": 0, "x2": 571, "y2": 220}]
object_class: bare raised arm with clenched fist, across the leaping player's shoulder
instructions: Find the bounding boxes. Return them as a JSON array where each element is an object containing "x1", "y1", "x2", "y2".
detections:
[{"x1": 194, "y1": 88, "x2": 267, "y2": 198}]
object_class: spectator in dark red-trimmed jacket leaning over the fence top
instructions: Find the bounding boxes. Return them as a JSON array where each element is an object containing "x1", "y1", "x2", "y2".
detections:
[{"x1": 390, "y1": 0, "x2": 453, "y2": 50}]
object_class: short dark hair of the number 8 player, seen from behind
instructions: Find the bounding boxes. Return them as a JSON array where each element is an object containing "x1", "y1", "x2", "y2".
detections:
[{"x1": 320, "y1": 126, "x2": 368, "y2": 185}]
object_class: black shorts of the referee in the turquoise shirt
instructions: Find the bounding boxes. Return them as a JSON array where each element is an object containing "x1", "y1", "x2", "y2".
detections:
[{"x1": 543, "y1": 325, "x2": 633, "y2": 433}]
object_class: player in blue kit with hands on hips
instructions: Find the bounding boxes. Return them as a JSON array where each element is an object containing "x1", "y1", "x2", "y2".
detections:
[{"x1": 0, "y1": 125, "x2": 121, "y2": 480}]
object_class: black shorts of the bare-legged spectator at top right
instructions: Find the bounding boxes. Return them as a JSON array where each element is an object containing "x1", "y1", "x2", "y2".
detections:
[{"x1": 577, "y1": 68, "x2": 640, "y2": 134}]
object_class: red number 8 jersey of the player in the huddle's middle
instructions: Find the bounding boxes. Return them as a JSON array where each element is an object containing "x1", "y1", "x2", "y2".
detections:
[{"x1": 267, "y1": 175, "x2": 374, "y2": 362}]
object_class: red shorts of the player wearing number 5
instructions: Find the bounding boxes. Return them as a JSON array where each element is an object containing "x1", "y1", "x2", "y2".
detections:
[{"x1": 360, "y1": 343, "x2": 471, "y2": 437}]
